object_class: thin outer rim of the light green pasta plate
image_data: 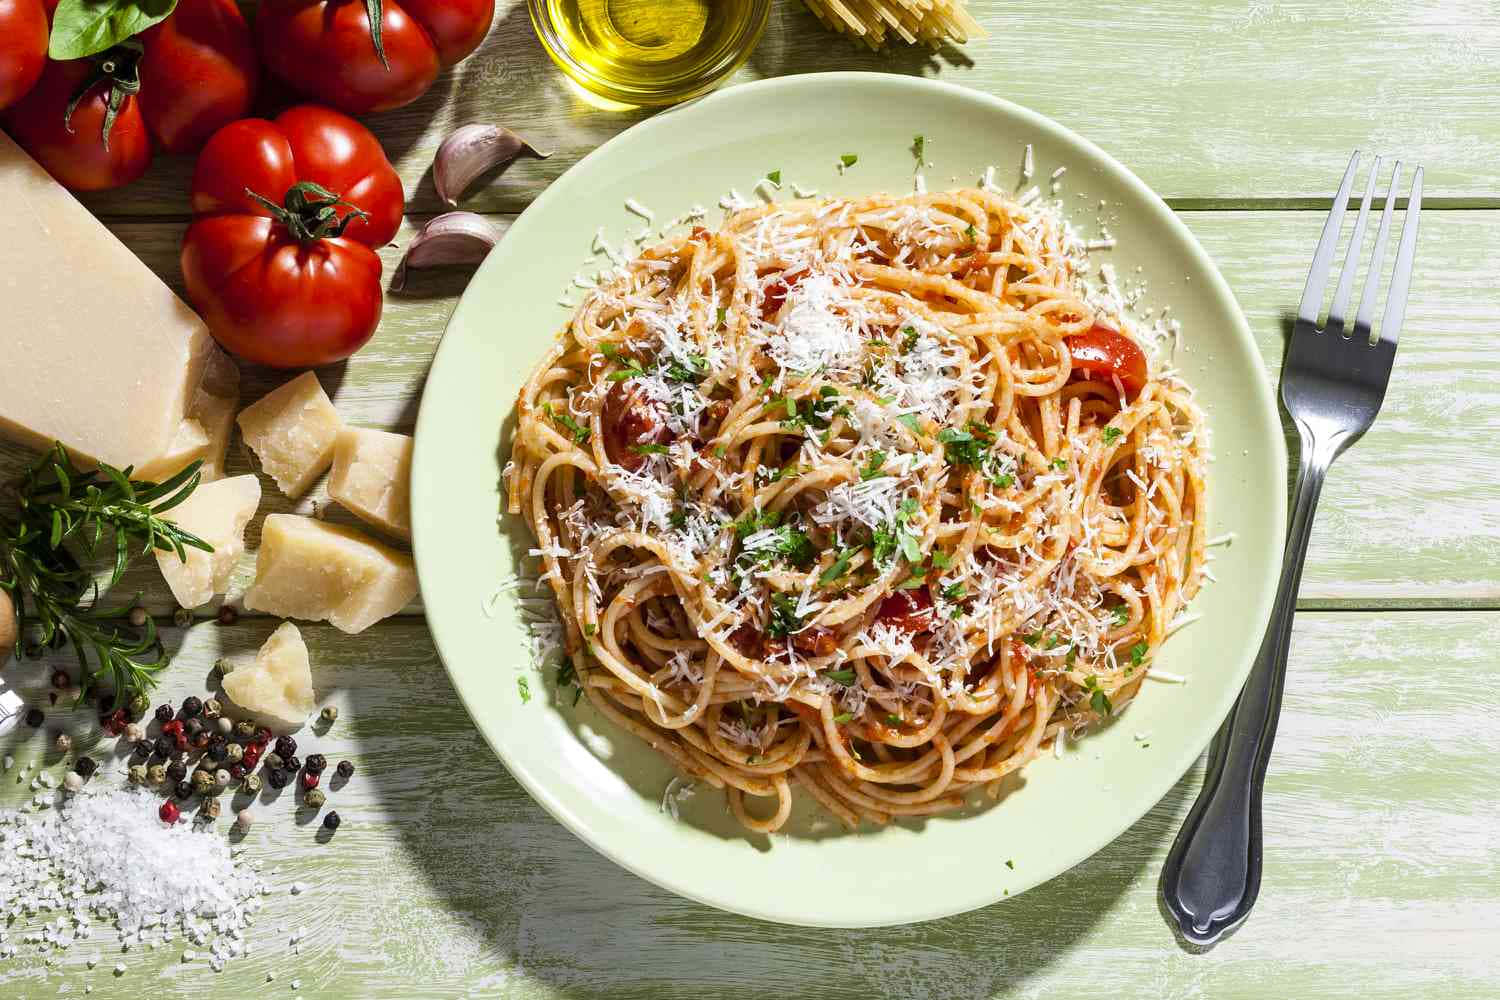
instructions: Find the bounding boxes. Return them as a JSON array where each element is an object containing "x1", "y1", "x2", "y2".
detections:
[{"x1": 411, "y1": 70, "x2": 1287, "y2": 928}]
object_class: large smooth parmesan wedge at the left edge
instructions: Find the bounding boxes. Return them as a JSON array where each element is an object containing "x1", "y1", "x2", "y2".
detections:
[{"x1": 0, "y1": 135, "x2": 213, "y2": 471}]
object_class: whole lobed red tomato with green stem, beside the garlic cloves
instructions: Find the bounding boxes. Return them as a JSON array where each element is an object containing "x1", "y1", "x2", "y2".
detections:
[{"x1": 182, "y1": 105, "x2": 404, "y2": 367}]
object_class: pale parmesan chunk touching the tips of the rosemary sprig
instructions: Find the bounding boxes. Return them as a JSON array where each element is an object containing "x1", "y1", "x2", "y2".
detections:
[{"x1": 156, "y1": 475, "x2": 261, "y2": 607}]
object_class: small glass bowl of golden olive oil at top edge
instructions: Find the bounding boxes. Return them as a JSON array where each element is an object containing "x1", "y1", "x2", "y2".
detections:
[{"x1": 528, "y1": 0, "x2": 771, "y2": 106}]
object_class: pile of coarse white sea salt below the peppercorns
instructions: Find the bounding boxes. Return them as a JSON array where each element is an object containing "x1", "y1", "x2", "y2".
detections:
[{"x1": 0, "y1": 789, "x2": 266, "y2": 970}]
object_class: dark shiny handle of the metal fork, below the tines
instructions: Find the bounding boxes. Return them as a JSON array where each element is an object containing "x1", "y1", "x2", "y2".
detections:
[{"x1": 1161, "y1": 427, "x2": 1338, "y2": 945}]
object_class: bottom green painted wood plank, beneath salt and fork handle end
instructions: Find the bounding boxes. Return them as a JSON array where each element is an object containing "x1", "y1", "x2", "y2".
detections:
[{"x1": 0, "y1": 613, "x2": 1500, "y2": 1000}]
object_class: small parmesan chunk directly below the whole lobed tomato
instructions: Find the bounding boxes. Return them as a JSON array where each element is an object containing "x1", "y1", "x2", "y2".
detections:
[{"x1": 240, "y1": 372, "x2": 342, "y2": 498}]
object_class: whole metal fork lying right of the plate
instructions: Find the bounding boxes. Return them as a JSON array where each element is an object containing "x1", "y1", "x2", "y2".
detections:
[{"x1": 1161, "y1": 150, "x2": 1422, "y2": 945}]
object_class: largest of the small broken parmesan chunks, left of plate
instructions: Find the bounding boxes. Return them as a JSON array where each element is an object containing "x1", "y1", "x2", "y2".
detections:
[{"x1": 245, "y1": 514, "x2": 417, "y2": 634}]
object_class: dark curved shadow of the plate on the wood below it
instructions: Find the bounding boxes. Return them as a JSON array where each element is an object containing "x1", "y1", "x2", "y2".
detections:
[{"x1": 350, "y1": 638, "x2": 1196, "y2": 1000}]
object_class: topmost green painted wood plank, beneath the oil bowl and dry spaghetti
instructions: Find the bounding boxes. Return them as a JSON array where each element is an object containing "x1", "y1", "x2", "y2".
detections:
[{"x1": 64, "y1": 0, "x2": 1500, "y2": 214}]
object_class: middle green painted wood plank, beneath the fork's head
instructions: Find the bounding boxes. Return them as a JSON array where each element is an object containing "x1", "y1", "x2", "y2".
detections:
[{"x1": 0, "y1": 211, "x2": 1500, "y2": 613}]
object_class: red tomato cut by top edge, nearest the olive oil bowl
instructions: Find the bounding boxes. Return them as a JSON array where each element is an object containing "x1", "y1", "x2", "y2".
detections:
[{"x1": 255, "y1": 0, "x2": 495, "y2": 114}]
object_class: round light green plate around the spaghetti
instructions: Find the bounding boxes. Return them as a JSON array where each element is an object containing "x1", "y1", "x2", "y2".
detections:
[{"x1": 413, "y1": 73, "x2": 1295, "y2": 927}]
